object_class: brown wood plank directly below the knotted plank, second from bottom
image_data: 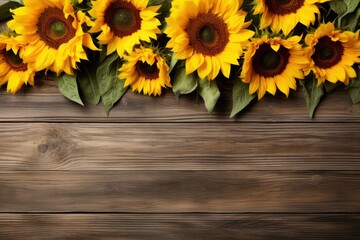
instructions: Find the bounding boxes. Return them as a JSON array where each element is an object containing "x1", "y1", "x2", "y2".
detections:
[{"x1": 0, "y1": 171, "x2": 360, "y2": 213}]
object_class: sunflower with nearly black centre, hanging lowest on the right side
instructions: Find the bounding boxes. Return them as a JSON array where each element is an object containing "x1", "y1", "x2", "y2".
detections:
[{"x1": 240, "y1": 35, "x2": 309, "y2": 100}]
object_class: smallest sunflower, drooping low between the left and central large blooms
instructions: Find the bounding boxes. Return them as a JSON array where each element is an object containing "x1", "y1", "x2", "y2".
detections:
[{"x1": 118, "y1": 46, "x2": 171, "y2": 96}]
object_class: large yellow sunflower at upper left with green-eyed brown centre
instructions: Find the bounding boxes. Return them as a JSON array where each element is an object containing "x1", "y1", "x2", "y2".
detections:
[{"x1": 8, "y1": 0, "x2": 98, "y2": 75}]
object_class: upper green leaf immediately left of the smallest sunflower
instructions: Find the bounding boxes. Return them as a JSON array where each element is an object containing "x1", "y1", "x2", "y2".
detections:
[{"x1": 96, "y1": 53, "x2": 120, "y2": 95}]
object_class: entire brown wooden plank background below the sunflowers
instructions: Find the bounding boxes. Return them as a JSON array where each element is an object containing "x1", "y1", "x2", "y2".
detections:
[{"x1": 0, "y1": 0, "x2": 360, "y2": 240}]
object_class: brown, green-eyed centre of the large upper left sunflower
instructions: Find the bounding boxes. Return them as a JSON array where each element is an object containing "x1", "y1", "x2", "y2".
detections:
[{"x1": 37, "y1": 7, "x2": 76, "y2": 49}]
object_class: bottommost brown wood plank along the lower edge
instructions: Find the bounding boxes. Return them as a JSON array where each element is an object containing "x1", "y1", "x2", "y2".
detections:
[{"x1": 0, "y1": 214, "x2": 360, "y2": 240}]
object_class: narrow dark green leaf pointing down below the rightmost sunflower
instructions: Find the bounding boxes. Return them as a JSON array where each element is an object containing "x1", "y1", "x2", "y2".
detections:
[{"x1": 300, "y1": 74, "x2": 324, "y2": 118}]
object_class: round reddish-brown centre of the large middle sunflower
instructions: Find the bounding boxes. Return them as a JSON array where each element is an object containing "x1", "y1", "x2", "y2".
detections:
[{"x1": 186, "y1": 13, "x2": 229, "y2": 56}]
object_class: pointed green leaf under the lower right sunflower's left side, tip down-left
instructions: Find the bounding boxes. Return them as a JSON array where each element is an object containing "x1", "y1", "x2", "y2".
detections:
[{"x1": 230, "y1": 78, "x2": 256, "y2": 118}]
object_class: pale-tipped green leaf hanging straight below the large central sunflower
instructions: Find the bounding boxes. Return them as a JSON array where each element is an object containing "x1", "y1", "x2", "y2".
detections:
[{"x1": 197, "y1": 78, "x2": 220, "y2": 113}]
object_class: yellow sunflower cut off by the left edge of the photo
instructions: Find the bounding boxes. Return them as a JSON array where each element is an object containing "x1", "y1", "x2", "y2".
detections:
[{"x1": 0, "y1": 35, "x2": 35, "y2": 94}]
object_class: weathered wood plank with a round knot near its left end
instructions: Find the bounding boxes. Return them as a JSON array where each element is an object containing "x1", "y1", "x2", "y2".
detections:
[{"x1": 0, "y1": 123, "x2": 360, "y2": 171}]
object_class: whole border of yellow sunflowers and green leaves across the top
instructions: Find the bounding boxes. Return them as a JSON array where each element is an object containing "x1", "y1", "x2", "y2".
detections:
[{"x1": 0, "y1": 0, "x2": 360, "y2": 117}]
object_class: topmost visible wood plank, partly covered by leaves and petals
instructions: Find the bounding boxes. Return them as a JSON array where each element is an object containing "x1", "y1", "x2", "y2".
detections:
[{"x1": 0, "y1": 80, "x2": 360, "y2": 122}]
